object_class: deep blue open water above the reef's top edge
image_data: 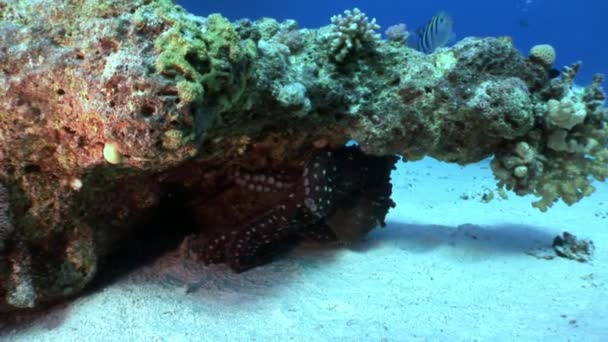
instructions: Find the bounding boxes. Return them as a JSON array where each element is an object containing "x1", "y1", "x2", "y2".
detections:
[{"x1": 177, "y1": 0, "x2": 608, "y2": 84}]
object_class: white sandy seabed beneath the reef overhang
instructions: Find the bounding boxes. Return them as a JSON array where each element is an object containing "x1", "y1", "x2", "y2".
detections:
[{"x1": 0, "y1": 160, "x2": 608, "y2": 341}]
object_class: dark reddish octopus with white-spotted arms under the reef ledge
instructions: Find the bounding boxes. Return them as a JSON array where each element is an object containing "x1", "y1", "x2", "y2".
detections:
[{"x1": 192, "y1": 147, "x2": 396, "y2": 272}]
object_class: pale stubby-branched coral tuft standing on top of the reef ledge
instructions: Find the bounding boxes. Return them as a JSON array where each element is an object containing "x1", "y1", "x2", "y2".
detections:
[{"x1": 329, "y1": 8, "x2": 380, "y2": 63}]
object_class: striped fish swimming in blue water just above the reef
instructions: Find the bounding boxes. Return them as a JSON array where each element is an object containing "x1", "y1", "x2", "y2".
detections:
[{"x1": 416, "y1": 11, "x2": 454, "y2": 53}]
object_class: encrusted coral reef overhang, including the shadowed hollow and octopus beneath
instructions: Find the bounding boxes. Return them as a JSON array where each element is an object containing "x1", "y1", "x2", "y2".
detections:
[{"x1": 0, "y1": 0, "x2": 608, "y2": 312}]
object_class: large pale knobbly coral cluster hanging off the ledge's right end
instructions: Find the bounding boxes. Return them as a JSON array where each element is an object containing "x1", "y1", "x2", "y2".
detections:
[{"x1": 492, "y1": 64, "x2": 608, "y2": 211}]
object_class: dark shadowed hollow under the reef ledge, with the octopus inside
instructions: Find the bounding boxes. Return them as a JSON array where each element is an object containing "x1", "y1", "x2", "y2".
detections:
[{"x1": 89, "y1": 142, "x2": 398, "y2": 283}]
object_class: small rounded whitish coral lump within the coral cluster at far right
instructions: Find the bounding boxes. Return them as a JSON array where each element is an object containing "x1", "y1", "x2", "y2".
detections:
[{"x1": 547, "y1": 94, "x2": 587, "y2": 130}]
